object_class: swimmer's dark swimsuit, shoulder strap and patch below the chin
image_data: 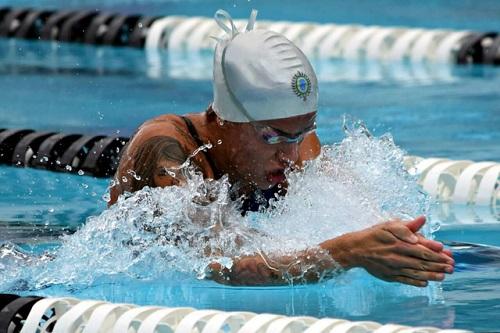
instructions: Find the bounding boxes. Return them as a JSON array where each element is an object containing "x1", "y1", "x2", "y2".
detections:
[{"x1": 180, "y1": 116, "x2": 280, "y2": 215}]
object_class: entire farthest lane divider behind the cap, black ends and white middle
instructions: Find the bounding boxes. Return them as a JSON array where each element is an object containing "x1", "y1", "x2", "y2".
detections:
[{"x1": 0, "y1": 7, "x2": 500, "y2": 65}]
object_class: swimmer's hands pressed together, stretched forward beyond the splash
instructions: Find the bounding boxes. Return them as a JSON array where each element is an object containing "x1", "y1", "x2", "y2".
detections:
[{"x1": 320, "y1": 217, "x2": 455, "y2": 287}]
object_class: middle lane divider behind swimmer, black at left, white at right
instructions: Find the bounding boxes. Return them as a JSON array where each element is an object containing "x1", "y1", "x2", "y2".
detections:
[{"x1": 0, "y1": 129, "x2": 500, "y2": 211}]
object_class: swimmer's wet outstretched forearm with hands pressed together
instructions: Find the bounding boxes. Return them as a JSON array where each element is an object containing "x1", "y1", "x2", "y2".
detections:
[{"x1": 205, "y1": 217, "x2": 454, "y2": 287}]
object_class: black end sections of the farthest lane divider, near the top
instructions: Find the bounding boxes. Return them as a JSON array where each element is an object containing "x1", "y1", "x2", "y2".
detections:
[{"x1": 0, "y1": 7, "x2": 500, "y2": 65}]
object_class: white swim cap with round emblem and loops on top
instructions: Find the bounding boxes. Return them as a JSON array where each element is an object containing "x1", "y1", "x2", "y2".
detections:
[{"x1": 212, "y1": 10, "x2": 318, "y2": 123}]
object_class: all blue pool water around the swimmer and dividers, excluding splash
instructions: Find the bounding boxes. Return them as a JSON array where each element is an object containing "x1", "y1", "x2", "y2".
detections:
[{"x1": 0, "y1": 0, "x2": 500, "y2": 331}]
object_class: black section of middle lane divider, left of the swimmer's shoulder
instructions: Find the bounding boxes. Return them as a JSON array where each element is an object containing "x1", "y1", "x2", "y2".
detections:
[{"x1": 0, "y1": 129, "x2": 129, "y2": 177}]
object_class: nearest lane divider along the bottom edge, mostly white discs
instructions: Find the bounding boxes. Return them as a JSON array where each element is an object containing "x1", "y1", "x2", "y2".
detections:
[{"x1": 0, "y1": 294, "x2": 470, "y2": 333}]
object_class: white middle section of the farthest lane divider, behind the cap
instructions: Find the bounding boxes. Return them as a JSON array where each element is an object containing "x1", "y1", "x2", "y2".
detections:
[{"x1": 145, "y1": 16, "x2": 473, "y2": 62}]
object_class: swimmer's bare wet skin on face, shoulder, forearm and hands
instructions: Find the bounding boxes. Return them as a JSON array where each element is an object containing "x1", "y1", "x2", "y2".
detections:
[{"x1": 110, "y1": 105, "x2": 454, "y2": 287}]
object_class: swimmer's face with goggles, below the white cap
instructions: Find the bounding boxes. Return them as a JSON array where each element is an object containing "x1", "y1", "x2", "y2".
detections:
[{"x1": 222, "y1": 112, "x2": 316, "y2": 189}]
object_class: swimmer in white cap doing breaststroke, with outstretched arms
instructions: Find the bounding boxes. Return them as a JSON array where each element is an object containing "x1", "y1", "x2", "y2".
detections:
[{"x1": 110, "y1": 10, "x2": 454, "y2": 287}]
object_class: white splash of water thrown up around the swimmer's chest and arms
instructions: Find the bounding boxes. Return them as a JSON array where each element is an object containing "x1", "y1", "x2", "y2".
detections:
[{"x1": 0, "y1": 121, "x2": 429, "y2": 290}]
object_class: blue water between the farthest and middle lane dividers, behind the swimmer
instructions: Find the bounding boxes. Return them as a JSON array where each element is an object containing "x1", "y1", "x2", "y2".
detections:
[{"x1": 0, "y1": 40, "x2": 500, "y2": 161}]
